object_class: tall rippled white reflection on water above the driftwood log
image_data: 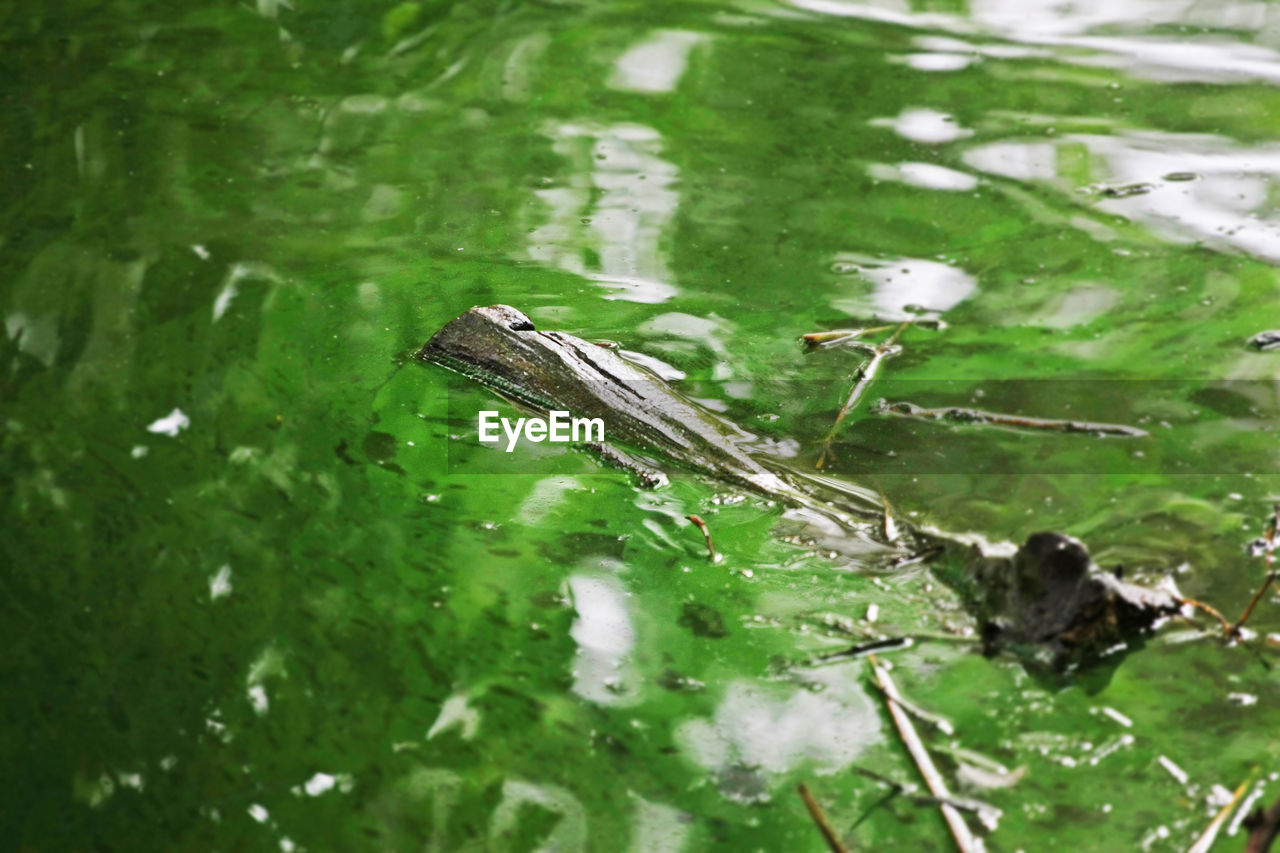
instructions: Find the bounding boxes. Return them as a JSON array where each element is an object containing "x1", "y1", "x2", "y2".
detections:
[{"x1": 529, "y1": 122, "x2": 680, "y2": 304}]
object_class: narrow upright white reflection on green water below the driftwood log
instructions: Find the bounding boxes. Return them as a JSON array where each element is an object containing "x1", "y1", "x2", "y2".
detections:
[{"x1": 568, "y1": 575, "x2": 637, "y2": 704}]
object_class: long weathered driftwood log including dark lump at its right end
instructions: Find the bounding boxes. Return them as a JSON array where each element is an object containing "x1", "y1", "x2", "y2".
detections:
[{"x1": 419, "y1": 305, "x2": 1181, "y2": 666}]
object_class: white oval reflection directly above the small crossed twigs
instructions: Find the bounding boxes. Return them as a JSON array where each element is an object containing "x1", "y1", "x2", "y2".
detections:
[{"x1": 831, "y1": 252, "x2": 978, "y2": 320}]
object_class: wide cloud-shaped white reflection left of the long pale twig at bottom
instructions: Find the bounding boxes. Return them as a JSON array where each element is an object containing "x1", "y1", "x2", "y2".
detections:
[{"x1": 676, "y1": 669, "x2": 881, "y2": 774}]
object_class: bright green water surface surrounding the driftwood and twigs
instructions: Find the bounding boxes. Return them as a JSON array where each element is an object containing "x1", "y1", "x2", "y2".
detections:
[{"x1": 0, "y1": 0, "x2": 1280, "y2": 850}]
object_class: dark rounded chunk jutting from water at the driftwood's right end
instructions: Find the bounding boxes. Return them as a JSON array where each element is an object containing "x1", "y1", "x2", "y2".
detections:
[{"x1": 972, "y1": 533, "x2": 1181, "y2": 670}]
